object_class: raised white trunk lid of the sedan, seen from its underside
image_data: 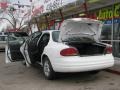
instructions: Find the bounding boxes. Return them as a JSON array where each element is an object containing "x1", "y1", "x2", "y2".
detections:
[{"x1": 58, "y1": 18, "x2": 103, "y2": 42}]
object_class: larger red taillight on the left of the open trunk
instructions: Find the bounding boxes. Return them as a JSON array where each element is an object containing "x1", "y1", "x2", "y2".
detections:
[{"x1": 60, "y1": 48, "x2": 78, "y2": 56}]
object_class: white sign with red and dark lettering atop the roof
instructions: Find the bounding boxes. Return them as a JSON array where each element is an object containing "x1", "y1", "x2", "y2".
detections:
[{"x1": 32, "y1": 0, "x2": 84, "y2": 15}]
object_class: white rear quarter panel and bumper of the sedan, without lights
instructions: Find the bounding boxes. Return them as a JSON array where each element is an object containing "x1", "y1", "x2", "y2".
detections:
[{"x1": 43, "y1": 32, "x2": 114, "y2": 72}]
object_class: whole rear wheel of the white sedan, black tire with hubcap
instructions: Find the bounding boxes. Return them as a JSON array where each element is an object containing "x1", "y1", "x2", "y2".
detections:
[{"x1": 43, "y1": 57, "x2": 55, "y2": 80}]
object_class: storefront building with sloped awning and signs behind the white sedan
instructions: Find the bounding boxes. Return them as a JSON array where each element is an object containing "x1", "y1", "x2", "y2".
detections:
[{"x1": 31, "y1": 0, "x2": 120, "y2": 57}]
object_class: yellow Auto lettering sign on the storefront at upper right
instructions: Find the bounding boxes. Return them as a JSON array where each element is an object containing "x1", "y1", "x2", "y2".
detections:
[{"x1": 98, "y1": 3, "x2": 120, "y2": 20}]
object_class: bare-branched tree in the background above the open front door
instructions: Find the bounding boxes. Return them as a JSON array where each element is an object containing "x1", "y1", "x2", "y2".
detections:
[{"x1": 0, "y1": 7, "x2": 29, "y2": 30}]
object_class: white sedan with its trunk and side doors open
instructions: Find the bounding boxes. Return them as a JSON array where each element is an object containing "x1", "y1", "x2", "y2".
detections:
[{"x1": 7, "y1": 18, "x2": 114, "y2": 79}]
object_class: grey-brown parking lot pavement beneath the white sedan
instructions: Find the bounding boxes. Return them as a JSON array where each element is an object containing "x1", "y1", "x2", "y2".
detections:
[{"x1": 0, "y1": 52, "x2": 120, "y2": 90}]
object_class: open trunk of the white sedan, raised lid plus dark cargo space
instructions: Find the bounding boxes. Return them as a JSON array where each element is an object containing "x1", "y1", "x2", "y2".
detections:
[{"x1": 58, "y1": 18, "x2": 106, "y2": 56}]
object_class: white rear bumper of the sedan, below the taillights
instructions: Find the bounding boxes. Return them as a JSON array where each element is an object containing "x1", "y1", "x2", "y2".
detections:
[{"x1": 52, "y1": 55, "x2": 114, "y2": 72}]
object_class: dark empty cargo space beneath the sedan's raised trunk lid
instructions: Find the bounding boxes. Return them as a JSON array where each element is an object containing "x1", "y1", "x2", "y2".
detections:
[{"x1": 68, "y1": 42, "x2": 106, "y2": 56}]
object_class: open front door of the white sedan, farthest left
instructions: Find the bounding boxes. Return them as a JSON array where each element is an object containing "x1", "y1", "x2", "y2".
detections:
[{"x1": 5, "y1": 32, "x2": 25, "y2": 63}]
